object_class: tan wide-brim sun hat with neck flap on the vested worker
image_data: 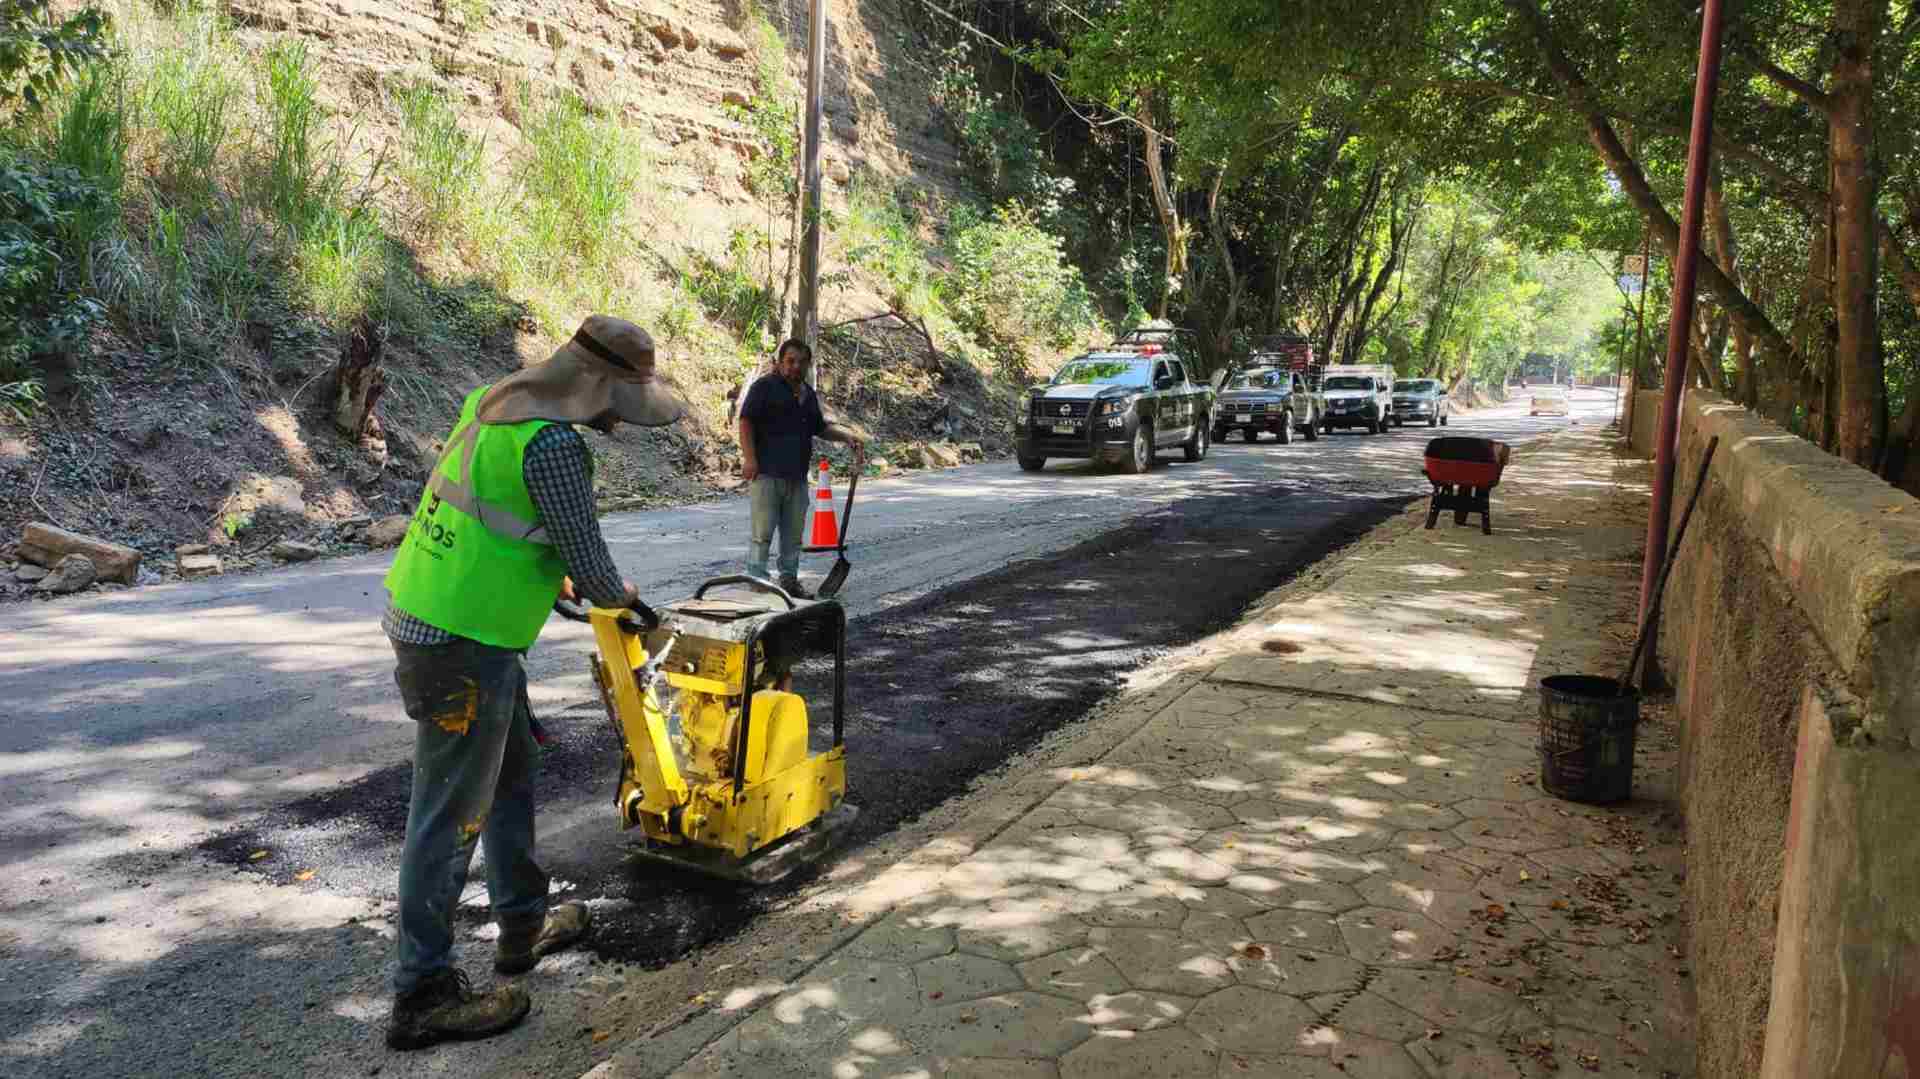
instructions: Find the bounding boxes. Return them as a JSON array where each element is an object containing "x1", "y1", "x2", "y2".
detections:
[{"x1": 476, "y1": 315, "x2": 687, "y2": 426}]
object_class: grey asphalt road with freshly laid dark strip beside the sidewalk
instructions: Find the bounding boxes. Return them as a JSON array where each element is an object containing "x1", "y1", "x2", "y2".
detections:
[{"x1": 0, "y1": 392, "x2": 1613, "y2": 1077}]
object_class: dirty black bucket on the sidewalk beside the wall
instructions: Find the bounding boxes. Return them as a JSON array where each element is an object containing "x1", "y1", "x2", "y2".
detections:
[{"x1": 1540, "y1": 674, "x2": 1640, "y2": 804}]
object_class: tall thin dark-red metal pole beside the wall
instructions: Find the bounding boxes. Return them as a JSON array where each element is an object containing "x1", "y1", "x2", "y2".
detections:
[{"x1": 1640, "y1": 0, "x2": 1722, "y2": 622}]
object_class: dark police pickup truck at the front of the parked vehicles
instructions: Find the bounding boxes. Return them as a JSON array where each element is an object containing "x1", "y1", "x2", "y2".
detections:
[{"x1": 1014, "y1": 342, "x2": 1212, "y2": 472}]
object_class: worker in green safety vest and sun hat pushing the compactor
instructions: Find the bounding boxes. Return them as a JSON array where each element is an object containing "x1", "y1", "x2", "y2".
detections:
[{"x1": 382, "y1": 315, "x2": 685, "y2": 1048}]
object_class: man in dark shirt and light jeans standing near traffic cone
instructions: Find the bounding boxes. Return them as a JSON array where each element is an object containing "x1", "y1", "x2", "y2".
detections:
[{"x1": 739, "y1": 340, "x2": 866, "y2": 599}]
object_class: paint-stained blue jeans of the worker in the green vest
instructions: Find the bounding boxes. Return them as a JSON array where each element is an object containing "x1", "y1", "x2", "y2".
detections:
[{"x1": 394, "y1": 639, "x2": 547, "y2": 993}]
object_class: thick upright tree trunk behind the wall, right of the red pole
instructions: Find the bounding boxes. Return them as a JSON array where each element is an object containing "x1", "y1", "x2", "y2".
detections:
[{"x1": 1828, "y1": 0, "x2": 1887, "y2": 468}]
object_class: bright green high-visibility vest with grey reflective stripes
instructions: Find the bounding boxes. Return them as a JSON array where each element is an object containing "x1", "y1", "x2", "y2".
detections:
[{"x1": 386, "y1": 386, "x2": 566, "y2": 649}]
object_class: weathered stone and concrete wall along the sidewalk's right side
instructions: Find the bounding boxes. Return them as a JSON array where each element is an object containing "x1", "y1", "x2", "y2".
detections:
[{"x1": 1632, "y1": 392, "x2": 1920, "y2": 1079}]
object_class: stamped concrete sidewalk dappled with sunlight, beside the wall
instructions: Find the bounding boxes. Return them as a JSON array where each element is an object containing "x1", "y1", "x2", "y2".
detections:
[{"x1": 618, "y1": 428, "x2": 1692, "y2": 1079}]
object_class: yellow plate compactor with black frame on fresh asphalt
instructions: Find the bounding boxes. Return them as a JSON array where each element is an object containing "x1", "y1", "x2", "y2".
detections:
[{"x1": 560, "y1": 576, "x2": 858, "y2": 883}]
